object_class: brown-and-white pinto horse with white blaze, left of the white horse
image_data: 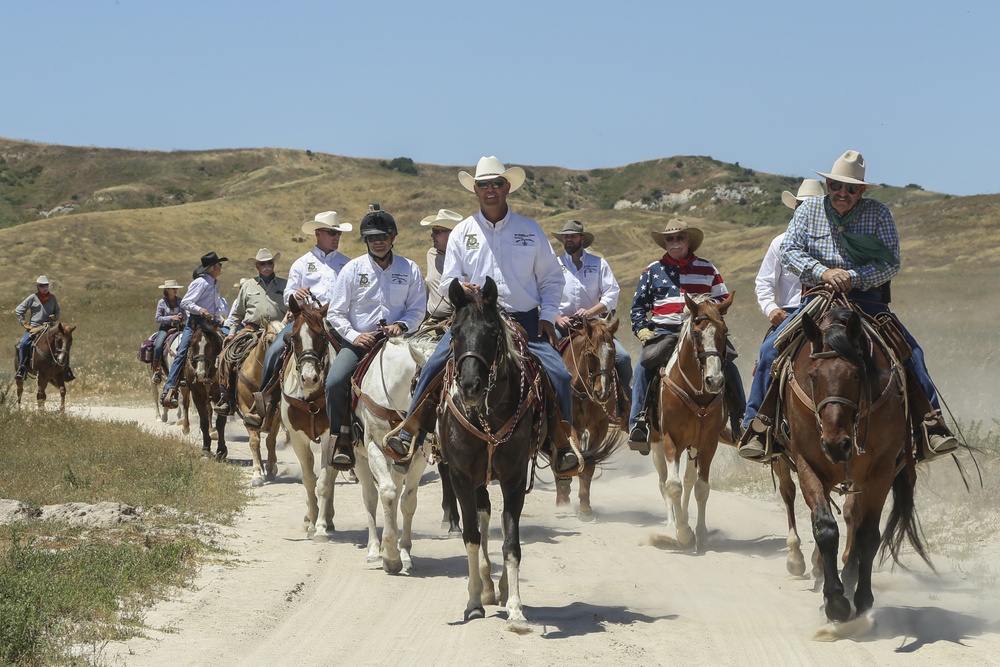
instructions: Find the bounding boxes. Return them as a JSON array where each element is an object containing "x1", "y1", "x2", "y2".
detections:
[{"x1": 281, "y1": 297, "x2": 337, "y2": 538}]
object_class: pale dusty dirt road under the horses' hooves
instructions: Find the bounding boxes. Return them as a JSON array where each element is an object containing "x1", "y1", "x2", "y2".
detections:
[{"x1": 66, "y1": 408, "x2": 1000, "y2": 666}]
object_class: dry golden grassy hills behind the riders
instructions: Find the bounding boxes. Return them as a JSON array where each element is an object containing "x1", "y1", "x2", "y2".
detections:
[{"x1": 0, "y1": 139, "x2": 1000, "y2": 422}]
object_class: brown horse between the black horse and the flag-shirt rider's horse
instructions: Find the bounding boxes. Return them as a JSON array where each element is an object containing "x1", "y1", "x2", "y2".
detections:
[{"x1": 556, "y1": 318, "x2": 627, "y2": 521}]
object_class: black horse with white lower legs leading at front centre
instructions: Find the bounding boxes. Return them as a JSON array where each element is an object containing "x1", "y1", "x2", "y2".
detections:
[{"x1": 438, "y1": 278, "x2": 612, "y2": 623}]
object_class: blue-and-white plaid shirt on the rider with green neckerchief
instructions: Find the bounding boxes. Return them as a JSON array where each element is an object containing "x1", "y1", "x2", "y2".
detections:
[{"x1": 781, "y1": 197, "x2": 899, "y2": 290}]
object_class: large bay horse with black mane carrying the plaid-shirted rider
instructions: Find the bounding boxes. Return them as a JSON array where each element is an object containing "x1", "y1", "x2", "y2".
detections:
[{"x1": 782, "y1": 308, "x2": 930, "y2": 621}]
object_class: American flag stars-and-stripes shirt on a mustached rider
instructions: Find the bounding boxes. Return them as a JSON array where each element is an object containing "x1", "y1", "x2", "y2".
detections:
[{"x1": 631, "y1": 254, "x2": 729, "y2": 334}]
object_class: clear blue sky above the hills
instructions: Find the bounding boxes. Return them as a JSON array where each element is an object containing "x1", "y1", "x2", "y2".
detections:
[{"x1": 0, "y1": 0, "x2": 1000, "y2": 195}]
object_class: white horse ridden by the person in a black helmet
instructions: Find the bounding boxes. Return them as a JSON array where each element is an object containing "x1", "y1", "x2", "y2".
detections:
[{"x1": 354, "y1": 337, "x2": 435, "y2": 574}]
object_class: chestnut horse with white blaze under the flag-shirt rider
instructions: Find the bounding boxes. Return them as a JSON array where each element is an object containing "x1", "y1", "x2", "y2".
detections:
[{"x1": 650, "y1": 294, "x2": 733, "y2": 553}]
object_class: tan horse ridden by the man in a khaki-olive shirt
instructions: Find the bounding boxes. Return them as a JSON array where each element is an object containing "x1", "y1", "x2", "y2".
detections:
[{"x1": 229, "y1": 322, "x2": 282, "y2": 486}]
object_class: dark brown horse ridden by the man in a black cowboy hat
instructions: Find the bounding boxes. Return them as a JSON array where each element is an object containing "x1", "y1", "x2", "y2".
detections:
[{"x1": 181, "y1": 322, "x2": 229, "y2": 461}]
